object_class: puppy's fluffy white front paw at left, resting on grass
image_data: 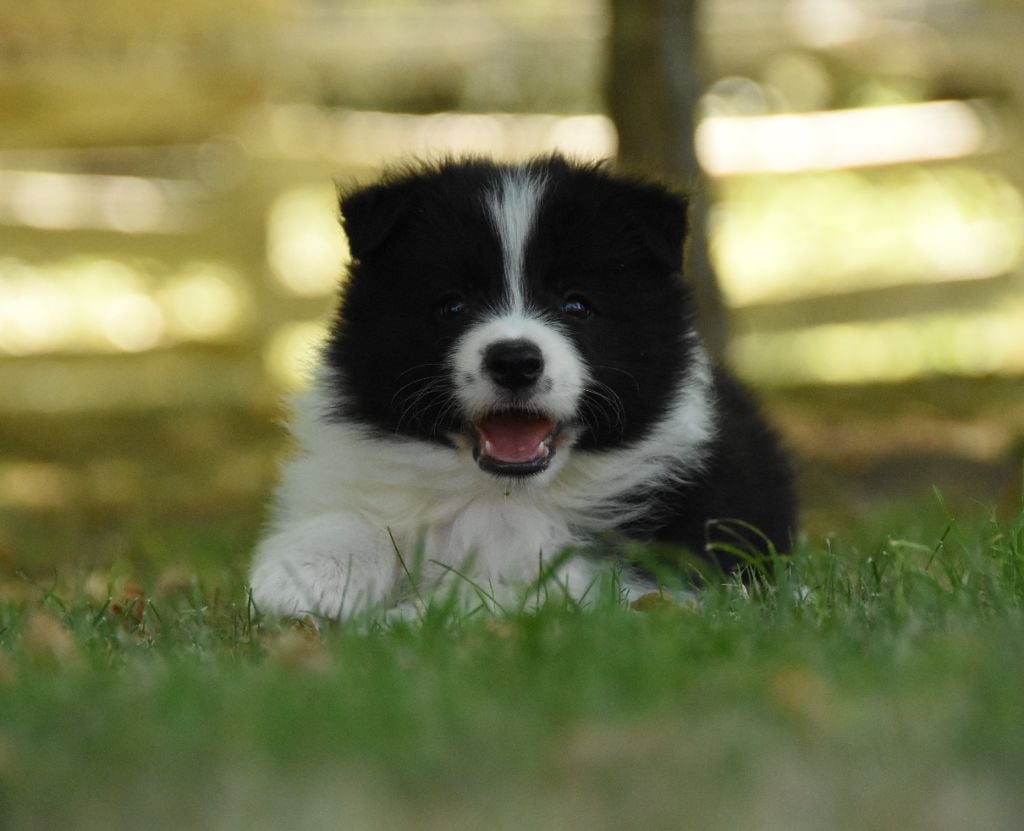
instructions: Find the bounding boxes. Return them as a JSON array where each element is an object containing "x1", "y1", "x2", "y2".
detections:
[{"x1": 250, "y1": 514, "x2": 397, "y2": 619}]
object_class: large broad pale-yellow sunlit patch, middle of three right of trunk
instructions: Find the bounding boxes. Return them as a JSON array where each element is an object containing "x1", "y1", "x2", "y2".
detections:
[{"x1": 709, "y1": 166, "x2": 1024, "y2": 306}]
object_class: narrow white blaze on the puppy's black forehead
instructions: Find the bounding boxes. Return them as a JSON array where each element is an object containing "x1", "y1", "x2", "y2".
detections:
[{"x1": 487, "y1": 168, "x2": 545, "y2": 311}]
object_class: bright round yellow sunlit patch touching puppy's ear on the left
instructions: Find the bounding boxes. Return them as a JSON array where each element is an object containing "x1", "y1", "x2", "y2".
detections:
[{"x1": 267, "y1": 186, "x2": 349, "y2": 297}]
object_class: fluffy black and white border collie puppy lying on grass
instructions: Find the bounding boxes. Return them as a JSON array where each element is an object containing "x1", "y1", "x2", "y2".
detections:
[{"x1": 251, "y1": 157, "x2": 795, "y2": 618}]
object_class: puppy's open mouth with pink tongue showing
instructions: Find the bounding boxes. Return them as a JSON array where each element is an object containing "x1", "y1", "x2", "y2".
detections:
[{"x1": 471, "y1": 410, "x2": 559, "y2": 476}]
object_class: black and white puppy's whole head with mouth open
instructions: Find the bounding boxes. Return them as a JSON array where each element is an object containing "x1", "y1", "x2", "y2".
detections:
[{"x1": 326, "y1": 157, "x2": 693, "y2": 479}]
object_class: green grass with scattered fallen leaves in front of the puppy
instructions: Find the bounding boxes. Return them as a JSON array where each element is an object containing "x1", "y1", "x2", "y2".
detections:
[{"x1": 0, "y1": 497, "x2": 1024, "y2": 831}]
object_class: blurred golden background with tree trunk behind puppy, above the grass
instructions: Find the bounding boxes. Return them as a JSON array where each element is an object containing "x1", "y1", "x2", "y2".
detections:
[{"x1": 0, "y1": 0, "x2": 1024, "y2": 573}]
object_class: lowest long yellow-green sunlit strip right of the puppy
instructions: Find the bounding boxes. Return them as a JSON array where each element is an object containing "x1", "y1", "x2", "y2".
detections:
[{"x1": 730, "y1": 301, "x2": 1024, "y2": 384}]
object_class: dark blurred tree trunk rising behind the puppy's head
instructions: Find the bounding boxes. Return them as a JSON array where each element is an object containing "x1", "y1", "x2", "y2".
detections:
[{"x1": 606, "y1": 0, "x2": 728, "y2": 355}]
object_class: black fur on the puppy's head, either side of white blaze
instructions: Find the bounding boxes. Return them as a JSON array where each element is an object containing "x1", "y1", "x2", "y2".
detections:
[{"x1": 326, "y1": 156, "x2": 694, "y2": 448}]
